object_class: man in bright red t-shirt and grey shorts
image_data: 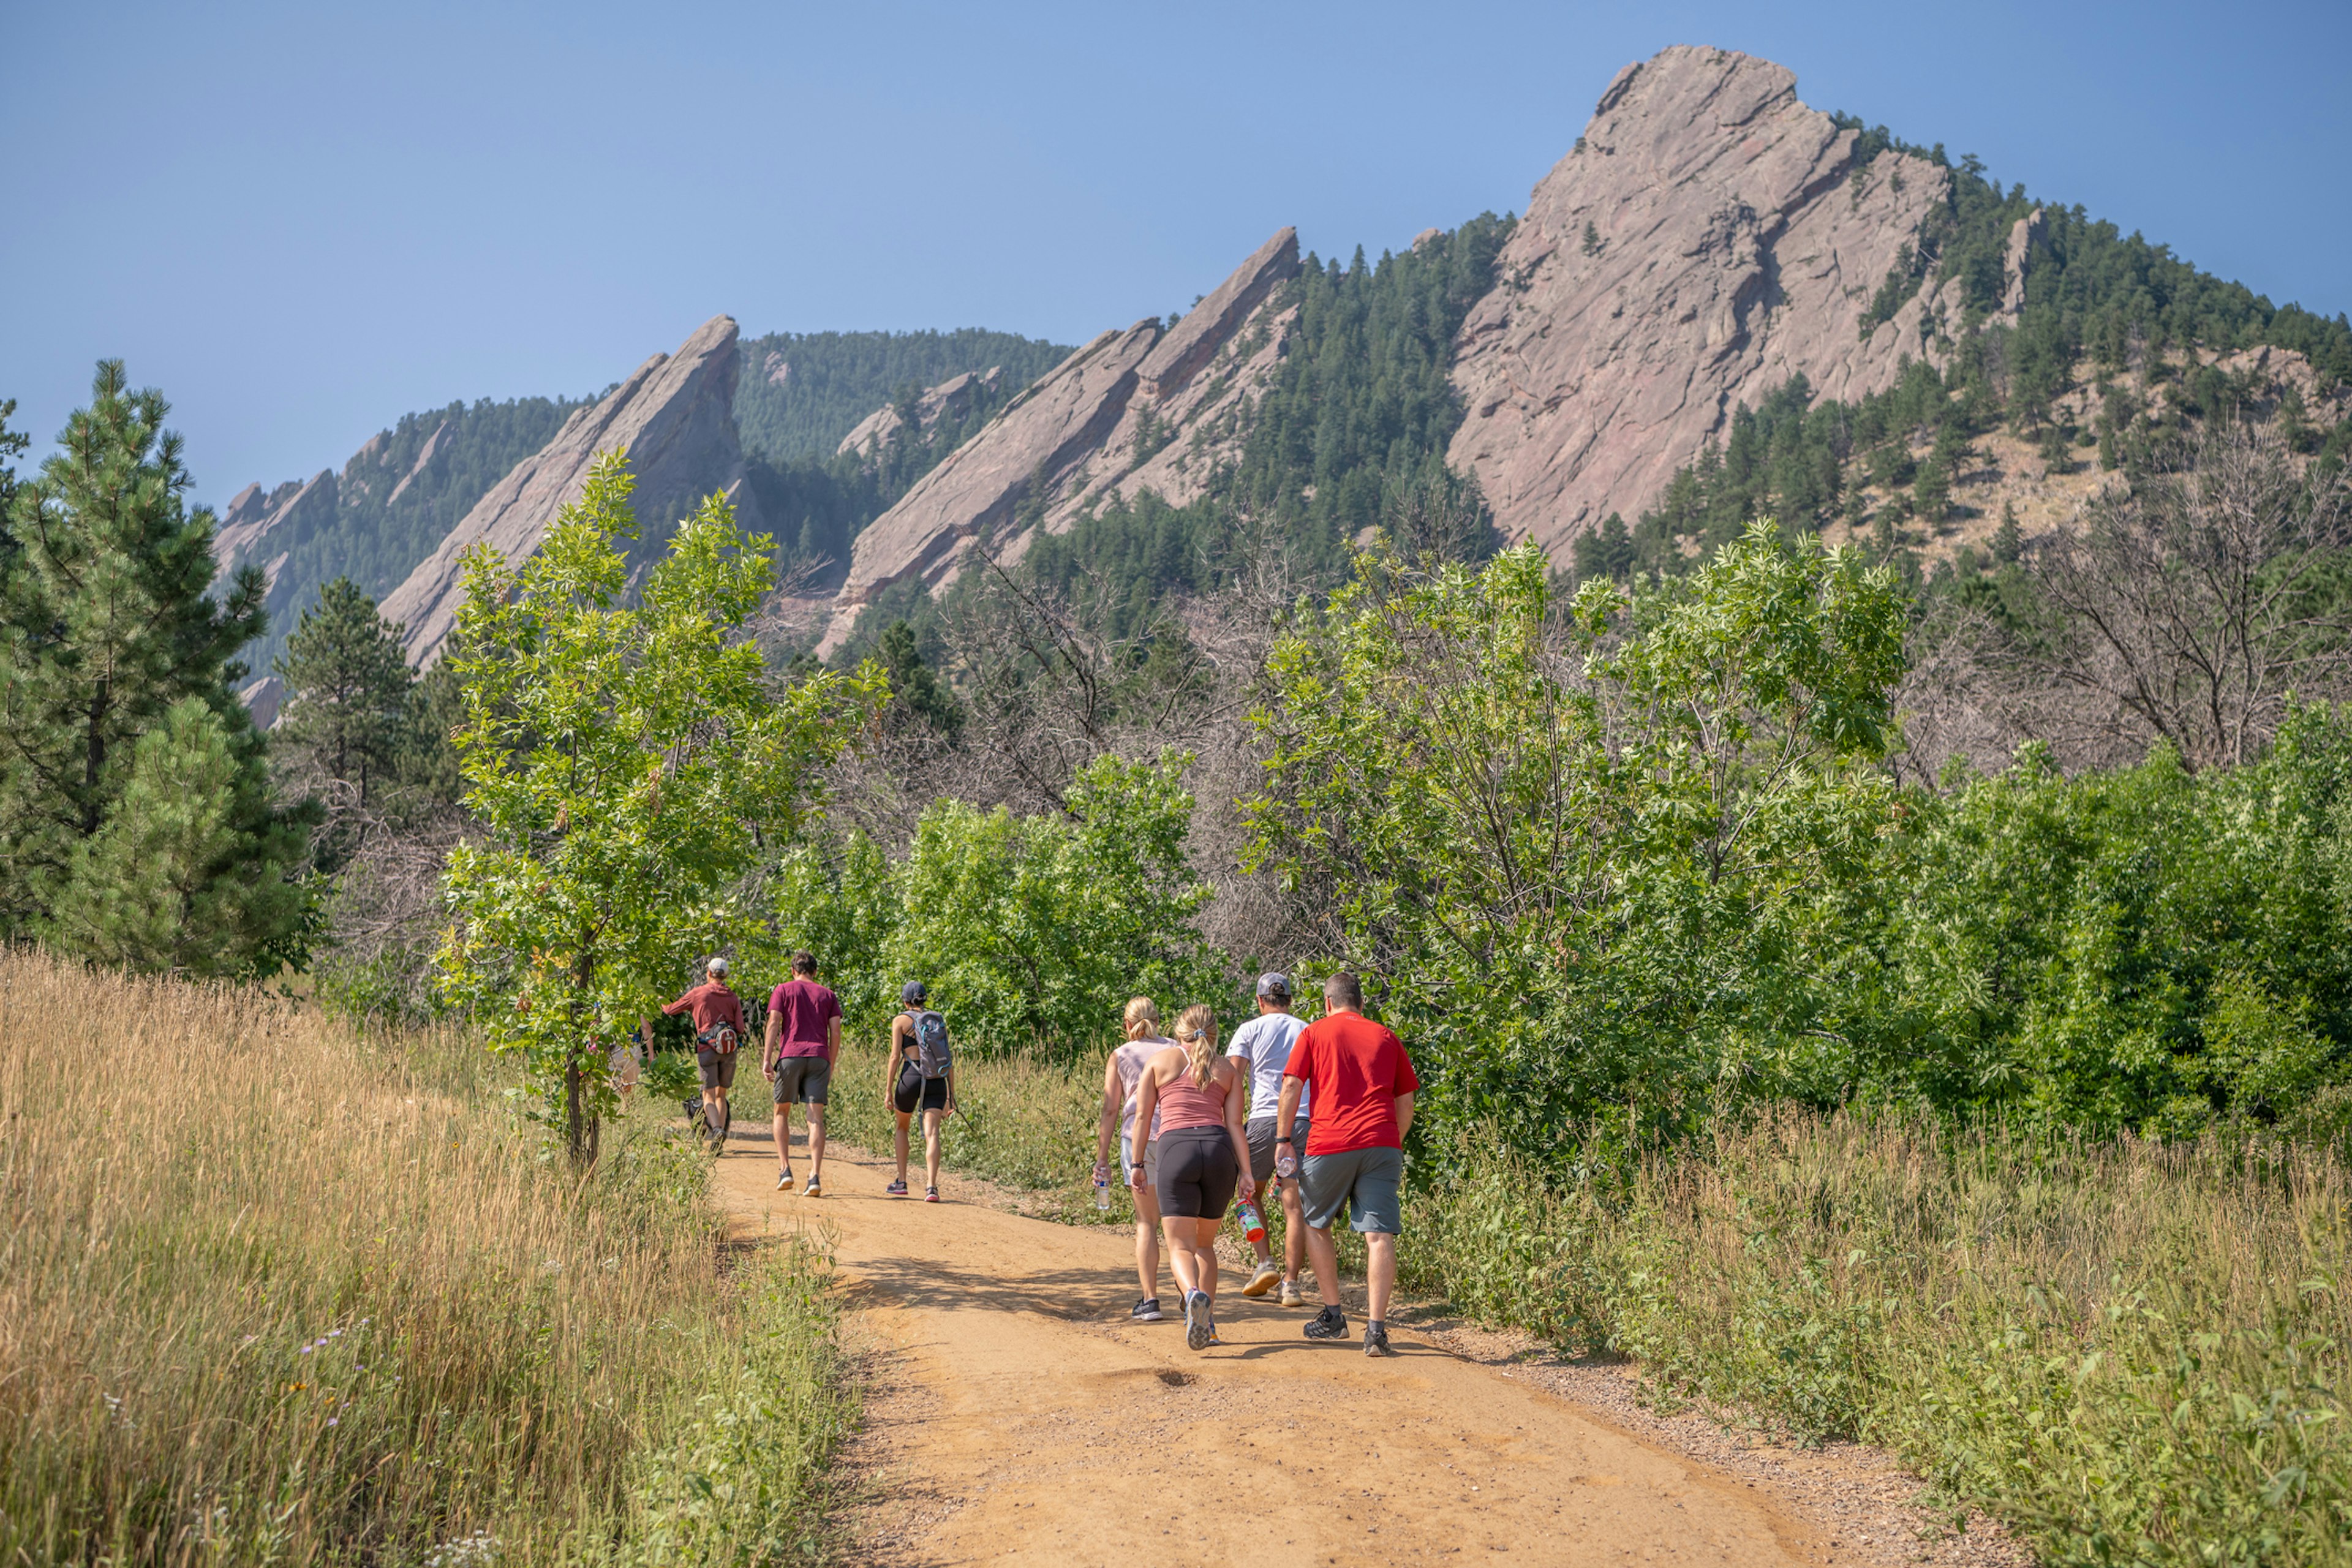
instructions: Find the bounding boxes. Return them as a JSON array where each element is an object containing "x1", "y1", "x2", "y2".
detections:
[{"x1": 1275, "y1": 973, "x2": 1420, "y2": 1357}]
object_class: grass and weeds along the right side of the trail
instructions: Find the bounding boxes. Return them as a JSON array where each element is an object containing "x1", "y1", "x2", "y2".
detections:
[{"x1": 832, "y1": 1046, "x2": 2352, "y2": 1566}]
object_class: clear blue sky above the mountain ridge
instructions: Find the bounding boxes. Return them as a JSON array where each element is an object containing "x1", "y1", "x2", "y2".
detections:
[{"x1": 0, "y1": 0, "x2": 2352, "y2": 501}]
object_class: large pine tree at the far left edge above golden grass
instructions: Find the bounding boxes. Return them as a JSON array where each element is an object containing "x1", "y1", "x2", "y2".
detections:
[{"x1": 0, "y1": 360, "x2": 315, "y2": 973}]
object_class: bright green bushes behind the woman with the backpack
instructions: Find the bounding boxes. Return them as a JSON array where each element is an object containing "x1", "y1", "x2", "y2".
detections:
[{"x1": 776, "y1": 755, "x2": 1230, "y2": 1058}]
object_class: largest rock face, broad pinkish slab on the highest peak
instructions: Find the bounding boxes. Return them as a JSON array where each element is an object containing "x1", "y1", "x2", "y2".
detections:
[{"x1": 1447, "y1": 47, "x2": 1948, "y2": 555}]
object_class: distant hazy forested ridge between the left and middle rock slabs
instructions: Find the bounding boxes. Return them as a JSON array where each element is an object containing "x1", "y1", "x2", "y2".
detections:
[{"x1": 734, "y1": 326, "x2": 1070, "y2": 461}]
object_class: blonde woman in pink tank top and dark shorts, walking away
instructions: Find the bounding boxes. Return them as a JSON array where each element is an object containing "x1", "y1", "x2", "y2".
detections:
[{"x1": 1126, "y1": 1004, "x2": 1256, "y2": 1349}]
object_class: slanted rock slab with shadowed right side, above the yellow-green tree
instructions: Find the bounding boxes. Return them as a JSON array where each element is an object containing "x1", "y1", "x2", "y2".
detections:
[{"x1": 381, "y1": 315, "x2": 764, "y2": 668}]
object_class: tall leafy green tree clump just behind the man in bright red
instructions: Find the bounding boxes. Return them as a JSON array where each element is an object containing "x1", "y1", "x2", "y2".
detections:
[{"x1": 1249, "y1": 524, "x2": 1903, "y2": 1150}]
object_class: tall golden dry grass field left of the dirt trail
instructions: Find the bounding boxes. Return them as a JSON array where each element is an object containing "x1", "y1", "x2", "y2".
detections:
[{"x1": 0, "y1": 952, "x2": 854, "y2": 1568}]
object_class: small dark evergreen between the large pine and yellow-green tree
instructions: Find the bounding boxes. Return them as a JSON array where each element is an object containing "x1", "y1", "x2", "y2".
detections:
[{"x1": 277, "y1": 576, "x2": 414, "y2": 811}]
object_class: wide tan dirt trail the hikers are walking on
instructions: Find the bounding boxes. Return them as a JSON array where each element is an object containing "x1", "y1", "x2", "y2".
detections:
[{"x1": 717, "y1": 1138, "x2": 1853, "y2": 1568}]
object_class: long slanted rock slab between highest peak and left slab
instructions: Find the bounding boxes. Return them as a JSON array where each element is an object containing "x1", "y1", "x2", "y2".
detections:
[{"x1": 818, "y1": 228, "x2": 1298, "y2": 656}]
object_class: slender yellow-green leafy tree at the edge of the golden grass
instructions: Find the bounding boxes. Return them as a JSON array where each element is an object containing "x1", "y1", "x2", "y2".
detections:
[{"x1": 440, "y1": 454, "x2": 887, "y2": 1159}]
